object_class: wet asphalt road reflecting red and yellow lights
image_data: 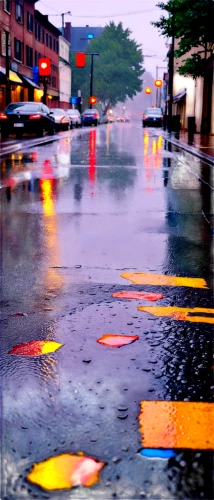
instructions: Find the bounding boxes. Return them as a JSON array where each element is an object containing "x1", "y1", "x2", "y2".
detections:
[{"x1": 0, "y1": 122, "x2": 213, "y2": 499}]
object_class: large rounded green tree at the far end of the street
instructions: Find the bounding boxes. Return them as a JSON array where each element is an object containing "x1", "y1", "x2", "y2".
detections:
[{"x1": 70, "y1": 22, "x2": 144, "y2": 110}]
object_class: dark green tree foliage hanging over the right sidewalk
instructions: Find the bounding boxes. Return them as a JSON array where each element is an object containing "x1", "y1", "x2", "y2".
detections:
[{"x1": 152, "y1": 0, "x2": 214, "y2": 78}]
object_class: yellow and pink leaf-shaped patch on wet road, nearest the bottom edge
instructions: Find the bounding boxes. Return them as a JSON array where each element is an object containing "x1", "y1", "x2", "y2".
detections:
[{"x1": 27, "y1": 453, "x2": 105, "y2": 491}]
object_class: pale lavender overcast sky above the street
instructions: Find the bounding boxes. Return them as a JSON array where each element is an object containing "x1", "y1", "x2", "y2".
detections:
[{"x1": 36, "y1": 0, "x2": 167, "y2": 78}]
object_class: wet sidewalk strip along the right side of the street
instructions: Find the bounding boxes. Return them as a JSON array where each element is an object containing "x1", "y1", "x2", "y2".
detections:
[{"x1": 164, "y1": 132, "x2": 214, "y2": 165}]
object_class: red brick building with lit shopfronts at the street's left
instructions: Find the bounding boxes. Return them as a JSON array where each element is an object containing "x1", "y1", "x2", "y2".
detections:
[{"x1": 0, "y1": 0, "x2": 61, "y2": 110}]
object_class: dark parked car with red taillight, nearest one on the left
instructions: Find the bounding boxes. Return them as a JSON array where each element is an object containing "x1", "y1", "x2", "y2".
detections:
[{"x1": 0, "y1": 102, "x2": 55, "y2": 138}]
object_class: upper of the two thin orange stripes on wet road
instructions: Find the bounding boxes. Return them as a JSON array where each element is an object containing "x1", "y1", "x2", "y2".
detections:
[{"x1": 120, "y1": 272, "x2": 208, "y2": 288}]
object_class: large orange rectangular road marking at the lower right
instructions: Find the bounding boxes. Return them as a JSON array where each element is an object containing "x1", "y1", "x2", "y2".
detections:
[{"x1": 139, "y1": 401, "x2": 214, "y2": 450}]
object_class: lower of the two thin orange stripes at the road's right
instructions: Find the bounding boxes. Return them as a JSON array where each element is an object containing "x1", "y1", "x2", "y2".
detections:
[{"x1": 137, "y1": 306, "x2": 214, "y2": 324}]
